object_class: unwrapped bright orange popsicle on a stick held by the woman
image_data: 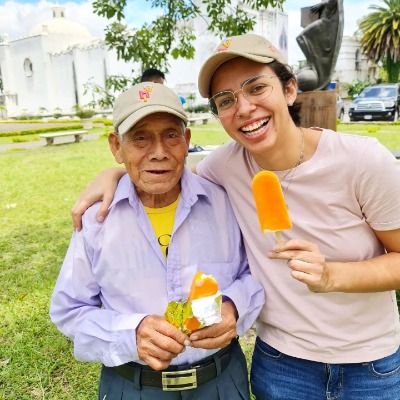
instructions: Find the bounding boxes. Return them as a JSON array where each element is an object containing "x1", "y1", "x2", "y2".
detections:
[{"x1": 252, "y1": 171, "x2": 292, "y2": 241}]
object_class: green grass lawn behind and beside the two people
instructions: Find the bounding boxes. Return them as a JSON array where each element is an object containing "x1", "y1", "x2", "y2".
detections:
[{"x1": 0, "y1": 123, "x2": 400, "y2": 400}]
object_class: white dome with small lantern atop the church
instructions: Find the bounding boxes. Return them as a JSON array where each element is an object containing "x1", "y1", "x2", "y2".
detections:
[{"x1": 30, "y1": 7, "x2": 92, "y2": 39}]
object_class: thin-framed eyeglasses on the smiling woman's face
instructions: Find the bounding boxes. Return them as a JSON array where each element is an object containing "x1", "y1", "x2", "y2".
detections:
[{"x1": 208, "y1": 75, "x2": 277, "y2": 118}]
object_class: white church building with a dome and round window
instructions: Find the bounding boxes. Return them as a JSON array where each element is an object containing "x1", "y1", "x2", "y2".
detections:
[{"x1": 0, "y1": 6, "x2": 133, "y2": 117}]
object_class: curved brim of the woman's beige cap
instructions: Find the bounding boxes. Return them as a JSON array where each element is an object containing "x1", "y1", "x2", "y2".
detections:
[{"x1": 198, "y1": 51, "x2": 275, "y2": 98}]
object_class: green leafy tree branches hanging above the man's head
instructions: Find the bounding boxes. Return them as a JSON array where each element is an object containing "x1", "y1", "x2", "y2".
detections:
[{"x1": 89, "y1": 0, "x2": 285, "y2": 108}]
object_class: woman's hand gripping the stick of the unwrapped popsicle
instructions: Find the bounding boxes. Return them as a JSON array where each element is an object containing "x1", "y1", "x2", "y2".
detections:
[{"x1": 268, "y1": 239, "x2": 334, "y2": 293}]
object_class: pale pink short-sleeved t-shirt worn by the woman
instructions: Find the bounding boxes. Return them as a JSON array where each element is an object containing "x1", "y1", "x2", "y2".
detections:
[{"x1": 197, "y1": 130, "x2": 400, "y2": 363}]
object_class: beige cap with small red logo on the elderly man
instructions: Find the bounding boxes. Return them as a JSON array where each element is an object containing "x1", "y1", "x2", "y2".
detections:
[{"x1": 113, "y1": 82, "x2": 188, "y2": 135}]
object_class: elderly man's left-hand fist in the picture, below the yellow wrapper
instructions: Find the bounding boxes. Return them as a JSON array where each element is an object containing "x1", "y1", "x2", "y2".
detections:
[{"x1": 136, "y1": 315, "x2": 189, "y2": 370}]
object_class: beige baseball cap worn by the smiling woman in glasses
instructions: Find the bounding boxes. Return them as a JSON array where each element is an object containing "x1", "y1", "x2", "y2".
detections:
[{"x1": 198, "y1": 33, "x2": 286, "y2": 97}]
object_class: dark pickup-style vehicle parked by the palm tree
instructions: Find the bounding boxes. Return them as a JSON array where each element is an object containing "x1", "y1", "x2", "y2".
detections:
[{"x1": 349, "y1": 83, "x2": 400, "y2": 121}]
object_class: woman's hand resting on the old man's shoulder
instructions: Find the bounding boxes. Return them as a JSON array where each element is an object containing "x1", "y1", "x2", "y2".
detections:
[{"x1": 71, "y1": 168, "x2": 126, "y2": 231}]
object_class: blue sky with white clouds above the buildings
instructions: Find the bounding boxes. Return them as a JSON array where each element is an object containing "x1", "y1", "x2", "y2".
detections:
[{"x1": 0, "y1": 0, "x2": 383, "y2": 64}]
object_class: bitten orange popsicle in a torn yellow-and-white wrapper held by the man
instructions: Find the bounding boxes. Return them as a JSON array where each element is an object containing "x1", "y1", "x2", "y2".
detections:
[{"x1": 164, "y1": 272, "x2": 222, "y2": 334}]
